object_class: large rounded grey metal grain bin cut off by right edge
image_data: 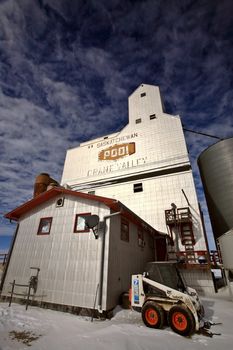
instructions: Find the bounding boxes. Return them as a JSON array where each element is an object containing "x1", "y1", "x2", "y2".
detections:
[{"x1": 198, "y1": 138, "x2": 233, "y2": 239}]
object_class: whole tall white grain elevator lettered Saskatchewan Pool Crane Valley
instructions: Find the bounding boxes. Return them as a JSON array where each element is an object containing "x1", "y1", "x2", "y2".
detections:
[{"x1": 61, "y1": 84, "x2": 208, "y2": 262}]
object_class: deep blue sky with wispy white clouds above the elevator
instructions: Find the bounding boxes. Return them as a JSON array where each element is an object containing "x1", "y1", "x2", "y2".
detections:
[{"x1": 0, "y1": 0, "x2": 233, "y2": 251}]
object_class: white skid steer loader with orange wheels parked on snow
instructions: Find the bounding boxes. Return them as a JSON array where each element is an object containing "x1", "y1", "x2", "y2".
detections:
[{"x1": 131, "y1": 262, "x2": 208, "y2": 336}]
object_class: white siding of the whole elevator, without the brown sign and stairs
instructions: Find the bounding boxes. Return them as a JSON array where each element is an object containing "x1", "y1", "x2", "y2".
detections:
[{"x1": 62, "y1": 84, "x2": 206, "y2": 250}]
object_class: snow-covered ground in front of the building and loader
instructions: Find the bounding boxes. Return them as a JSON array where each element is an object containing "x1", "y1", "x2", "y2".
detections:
[{"x1": 0, "y1": 292, "x2": 233, "y2": 350}]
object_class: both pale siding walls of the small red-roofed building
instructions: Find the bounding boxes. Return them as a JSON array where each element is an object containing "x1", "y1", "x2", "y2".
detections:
[{"x1": 3, "y1": 195, "x2": 162, "y2": 310}]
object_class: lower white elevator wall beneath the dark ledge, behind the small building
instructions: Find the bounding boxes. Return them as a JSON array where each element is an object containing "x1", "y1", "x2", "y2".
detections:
[{"x1": 86, "y1": 172, "x2": 205, "y2": 250}]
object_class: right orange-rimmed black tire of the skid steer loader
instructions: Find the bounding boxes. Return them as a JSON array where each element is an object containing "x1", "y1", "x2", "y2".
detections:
[{"x1": 168, "y1": 305, "x2": 195, "y2": 336}]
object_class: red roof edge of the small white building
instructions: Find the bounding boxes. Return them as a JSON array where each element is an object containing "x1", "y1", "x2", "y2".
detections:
[{"x1": 5, "y1": 187, "x2": 164, "y2": 237}]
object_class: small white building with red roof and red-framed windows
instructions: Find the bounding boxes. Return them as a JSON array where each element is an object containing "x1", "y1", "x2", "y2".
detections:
[{"x1": 1, "y1": 187, "x2": 166, "y2": 311}]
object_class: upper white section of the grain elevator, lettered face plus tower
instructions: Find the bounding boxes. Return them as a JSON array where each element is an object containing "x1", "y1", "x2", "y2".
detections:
[{"x1": 62, "y1": 85, "x2": 189, "y2": 186}]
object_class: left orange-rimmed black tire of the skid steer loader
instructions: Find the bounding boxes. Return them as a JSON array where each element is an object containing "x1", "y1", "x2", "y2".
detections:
[{"x1": 142, "y1": 301, "x2": 164, "y2": 328}]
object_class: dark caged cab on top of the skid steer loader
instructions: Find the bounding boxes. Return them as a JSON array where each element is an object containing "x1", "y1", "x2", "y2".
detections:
[{"x1": 144, "y1": 261, "x2": 187, "y2": 293}]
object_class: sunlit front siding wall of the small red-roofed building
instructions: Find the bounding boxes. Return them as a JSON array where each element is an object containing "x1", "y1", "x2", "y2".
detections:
[{"x1": 3, "y1": 197, "x2": 109, "y2": 308}]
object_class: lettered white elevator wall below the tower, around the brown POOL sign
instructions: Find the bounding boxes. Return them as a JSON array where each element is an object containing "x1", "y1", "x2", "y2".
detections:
[{"x1": 61, "y1": 110, "x2": 189, "y2": 188}]
